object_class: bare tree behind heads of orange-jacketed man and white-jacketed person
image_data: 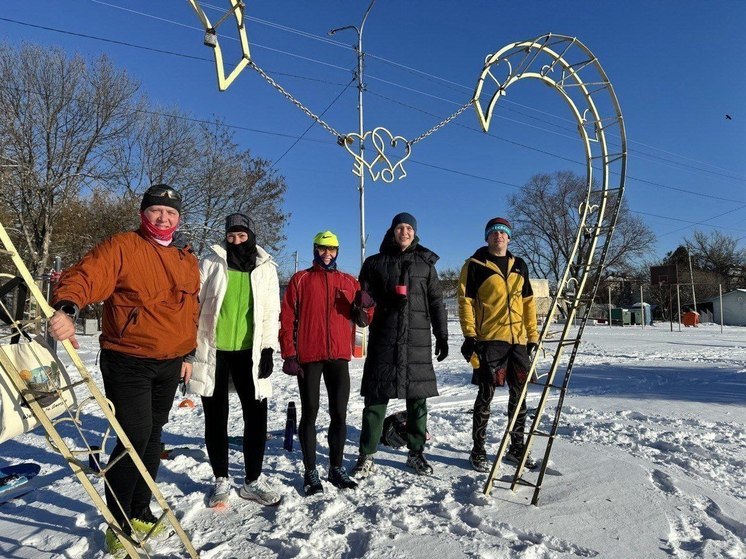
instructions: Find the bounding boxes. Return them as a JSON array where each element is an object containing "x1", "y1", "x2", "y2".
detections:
[{"x1": 110, "y1": 114, "x2": 289, "y2": 254}]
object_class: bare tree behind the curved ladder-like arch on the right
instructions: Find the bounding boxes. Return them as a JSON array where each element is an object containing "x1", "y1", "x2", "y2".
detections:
[{"x1": 508, "y1": 171, "x2": 655, "y2": 283}]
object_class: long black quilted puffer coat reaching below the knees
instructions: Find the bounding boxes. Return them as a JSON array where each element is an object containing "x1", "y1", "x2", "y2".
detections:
[{"x1": 360, "y1": 229, "x2": 448, "y2": 399}]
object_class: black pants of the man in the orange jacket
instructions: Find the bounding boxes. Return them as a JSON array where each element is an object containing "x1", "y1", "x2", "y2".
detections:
[{"x1": 101, "y1": 349, "x2": 183, "y2": 531}]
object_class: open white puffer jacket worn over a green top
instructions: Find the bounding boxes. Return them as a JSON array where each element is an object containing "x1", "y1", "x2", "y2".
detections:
[{"x1": 189, "y1": 243, "x2": 280, "y2": 400}]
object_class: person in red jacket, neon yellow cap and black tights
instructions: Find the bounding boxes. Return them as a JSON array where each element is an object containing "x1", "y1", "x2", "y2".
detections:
[{"x1": 280, "y1": 231, "x2": 373, "y2": 495}]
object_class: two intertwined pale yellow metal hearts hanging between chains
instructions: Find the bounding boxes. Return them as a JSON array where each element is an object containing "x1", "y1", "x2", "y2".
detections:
[{"x1": 343, "y1": 126, "x2": 412, "y2": 183}]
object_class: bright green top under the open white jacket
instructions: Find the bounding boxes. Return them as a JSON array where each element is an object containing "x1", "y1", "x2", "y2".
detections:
[{"x1": 215, "y1": 270, "x2": 254, "y2": 351}]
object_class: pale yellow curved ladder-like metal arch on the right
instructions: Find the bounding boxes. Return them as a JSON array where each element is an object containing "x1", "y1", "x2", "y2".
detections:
[{"x1": 474, "y1": 34, "x2": 627, "y2": 505}]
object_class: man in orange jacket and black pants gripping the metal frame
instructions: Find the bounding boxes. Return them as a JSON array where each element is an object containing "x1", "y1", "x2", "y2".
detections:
[{"x1": 49, "y1": 184, "x2": 199, "y2": 552}]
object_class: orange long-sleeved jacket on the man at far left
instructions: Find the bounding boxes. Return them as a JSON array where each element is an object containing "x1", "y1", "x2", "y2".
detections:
[{"x1": 54, "y1": 231, "x2": 199, "y2": 359}]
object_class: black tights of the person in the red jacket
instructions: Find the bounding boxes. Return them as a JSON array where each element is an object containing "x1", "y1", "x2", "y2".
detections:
[{"x1": 298, "y1": 359, "x2": 350, "y2": 470}]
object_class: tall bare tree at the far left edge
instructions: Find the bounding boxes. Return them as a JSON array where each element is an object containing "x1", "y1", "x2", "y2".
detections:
[{"x1": 0, "y1": 44, "x2": 139, "y2": 274}]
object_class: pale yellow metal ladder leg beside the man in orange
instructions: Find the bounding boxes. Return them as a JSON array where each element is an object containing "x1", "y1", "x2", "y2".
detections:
[{"x1": 0, "y1": 223, "x2": 199, "y2": 559}]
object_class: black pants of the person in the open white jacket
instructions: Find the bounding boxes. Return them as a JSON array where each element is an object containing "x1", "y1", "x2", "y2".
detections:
[{"x1": 202, "y1": 349, "x2": 267, "y2": 483}]
